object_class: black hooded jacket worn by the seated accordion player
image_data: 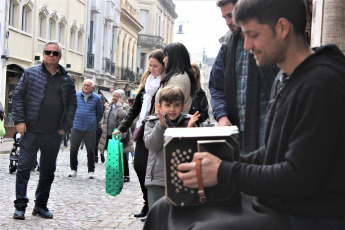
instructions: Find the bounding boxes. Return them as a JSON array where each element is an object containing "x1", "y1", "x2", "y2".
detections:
[{"x1": 218, "y1": 45, "x2": 345, "y2": 218}]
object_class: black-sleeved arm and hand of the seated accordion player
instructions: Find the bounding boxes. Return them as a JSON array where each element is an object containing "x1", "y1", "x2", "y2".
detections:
[{"x1": 178, "y1": 77, "x2": 345, "y2": 199}]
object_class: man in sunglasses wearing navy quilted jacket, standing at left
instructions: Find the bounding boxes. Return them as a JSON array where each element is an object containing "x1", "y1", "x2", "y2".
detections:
[{"x1": 13, "y1": 41, "x2": 77, "y2": 220}]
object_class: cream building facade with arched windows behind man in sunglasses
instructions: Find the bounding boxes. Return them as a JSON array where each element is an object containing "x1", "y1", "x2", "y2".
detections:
[{"x1": 3, "y1": 0, "x2": 86, "y2": 136}]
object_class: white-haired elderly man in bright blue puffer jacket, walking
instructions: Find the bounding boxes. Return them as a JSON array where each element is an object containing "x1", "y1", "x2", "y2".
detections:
[{"x1": 68, "y1": 79, "x2": 103, "y2": 179}]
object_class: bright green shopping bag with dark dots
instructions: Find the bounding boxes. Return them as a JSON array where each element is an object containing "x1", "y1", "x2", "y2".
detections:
[{"x1": 105, "y1": 131, "x2": 123, "y2": 196}]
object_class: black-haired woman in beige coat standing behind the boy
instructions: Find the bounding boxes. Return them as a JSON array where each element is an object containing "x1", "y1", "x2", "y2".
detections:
[{"x1": 155, "y1": 42, "x2": 196, "y2": 114}]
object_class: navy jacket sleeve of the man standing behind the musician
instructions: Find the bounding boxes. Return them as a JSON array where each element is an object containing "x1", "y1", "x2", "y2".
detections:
[{"x1": 208, "y1": 46, "x2": 228, "y2": 121}]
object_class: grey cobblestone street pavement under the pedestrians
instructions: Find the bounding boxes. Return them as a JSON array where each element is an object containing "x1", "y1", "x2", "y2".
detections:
[{"x1": 0, "y1": 139, "x2": 143, "y2": 230}]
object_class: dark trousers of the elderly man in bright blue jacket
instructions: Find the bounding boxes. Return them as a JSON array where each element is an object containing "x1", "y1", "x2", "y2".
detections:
[{"x1": 70, "y1": 129, "x2": 96, "y2": 172}]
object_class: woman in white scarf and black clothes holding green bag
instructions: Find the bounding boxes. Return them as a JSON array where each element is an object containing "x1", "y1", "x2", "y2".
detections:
[{"x1": 113, "y1": 49, "x2": 164, "y2": 220}]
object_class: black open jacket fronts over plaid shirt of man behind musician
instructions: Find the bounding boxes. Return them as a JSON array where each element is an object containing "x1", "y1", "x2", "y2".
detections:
[{"x1": 224, "y1": 34, "x2": 278, "y2": 152}]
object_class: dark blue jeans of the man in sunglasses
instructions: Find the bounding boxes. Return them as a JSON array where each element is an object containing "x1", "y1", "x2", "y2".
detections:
[{"x1": 14, "y1": 132, "x2": 62, "y2": 209}]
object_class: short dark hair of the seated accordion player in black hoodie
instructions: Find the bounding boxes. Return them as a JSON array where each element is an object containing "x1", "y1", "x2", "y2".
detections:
[{"x1": 233, "y1": 0, "x2": 307, "y2": 36}]
